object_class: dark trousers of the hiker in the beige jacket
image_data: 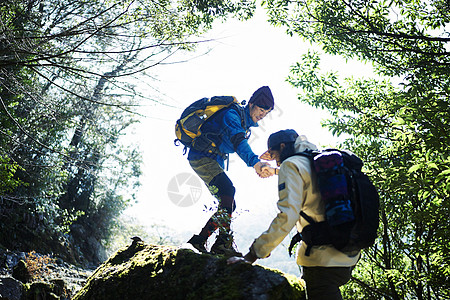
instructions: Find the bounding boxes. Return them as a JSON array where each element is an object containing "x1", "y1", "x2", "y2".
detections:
[{"x1": 302, "y1": 267, "x2": 353, "y2": 300}]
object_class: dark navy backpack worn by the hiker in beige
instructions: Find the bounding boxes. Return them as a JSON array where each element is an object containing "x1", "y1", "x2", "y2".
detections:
[{"x1": 289, "y1": 149, "x2": 379, "y2": 256}]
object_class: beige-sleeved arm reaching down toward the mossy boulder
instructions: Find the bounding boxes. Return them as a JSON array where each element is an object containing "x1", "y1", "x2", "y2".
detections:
[{"x1": 251, "y1": 161, "x2": 303, "y2": 258}]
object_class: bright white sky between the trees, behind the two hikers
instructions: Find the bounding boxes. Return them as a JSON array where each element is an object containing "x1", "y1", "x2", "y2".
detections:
[{"x1": 124, "y1": 6, "x2": 368, "y2": 273}]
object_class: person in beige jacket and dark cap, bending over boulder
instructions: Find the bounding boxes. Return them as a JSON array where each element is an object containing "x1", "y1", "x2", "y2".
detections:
[{"x1": 228, "y1": 129, "x2": 360, "y2": 299}]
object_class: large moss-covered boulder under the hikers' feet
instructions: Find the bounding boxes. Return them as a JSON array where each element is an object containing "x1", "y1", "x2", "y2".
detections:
[{"x1": 72, "y1": 242, "x2": 305, "y2": 300}]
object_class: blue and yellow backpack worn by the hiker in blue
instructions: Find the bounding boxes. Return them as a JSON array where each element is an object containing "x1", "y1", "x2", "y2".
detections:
[{"x1": 174, "y1": 96, "x2": 246, "y2": 156}]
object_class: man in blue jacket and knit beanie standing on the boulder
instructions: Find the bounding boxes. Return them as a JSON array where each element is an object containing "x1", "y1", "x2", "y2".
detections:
[{"x1": 188, "y1": 86, "x2": 274, "y2": 256}]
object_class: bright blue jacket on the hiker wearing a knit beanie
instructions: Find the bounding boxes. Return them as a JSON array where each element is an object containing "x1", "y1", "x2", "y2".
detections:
[{"x1": 188, "y1": 105, "x2": 259, "y2": 168}]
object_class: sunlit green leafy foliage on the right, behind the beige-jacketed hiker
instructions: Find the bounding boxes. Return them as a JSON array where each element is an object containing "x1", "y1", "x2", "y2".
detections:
[{"x1": 264, "y1": 0, "x2": 450, "y2": 299}]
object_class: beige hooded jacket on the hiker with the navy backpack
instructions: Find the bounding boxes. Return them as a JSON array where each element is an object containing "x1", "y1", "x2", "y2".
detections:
[{"x1": 250, "y1": 136, "x2": 360, "y2": 267}]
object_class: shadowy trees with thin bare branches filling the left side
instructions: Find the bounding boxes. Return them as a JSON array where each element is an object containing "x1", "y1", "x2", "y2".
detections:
[{"x1": 0, "y1": 0, "x2": 254, "y2": 263}]
